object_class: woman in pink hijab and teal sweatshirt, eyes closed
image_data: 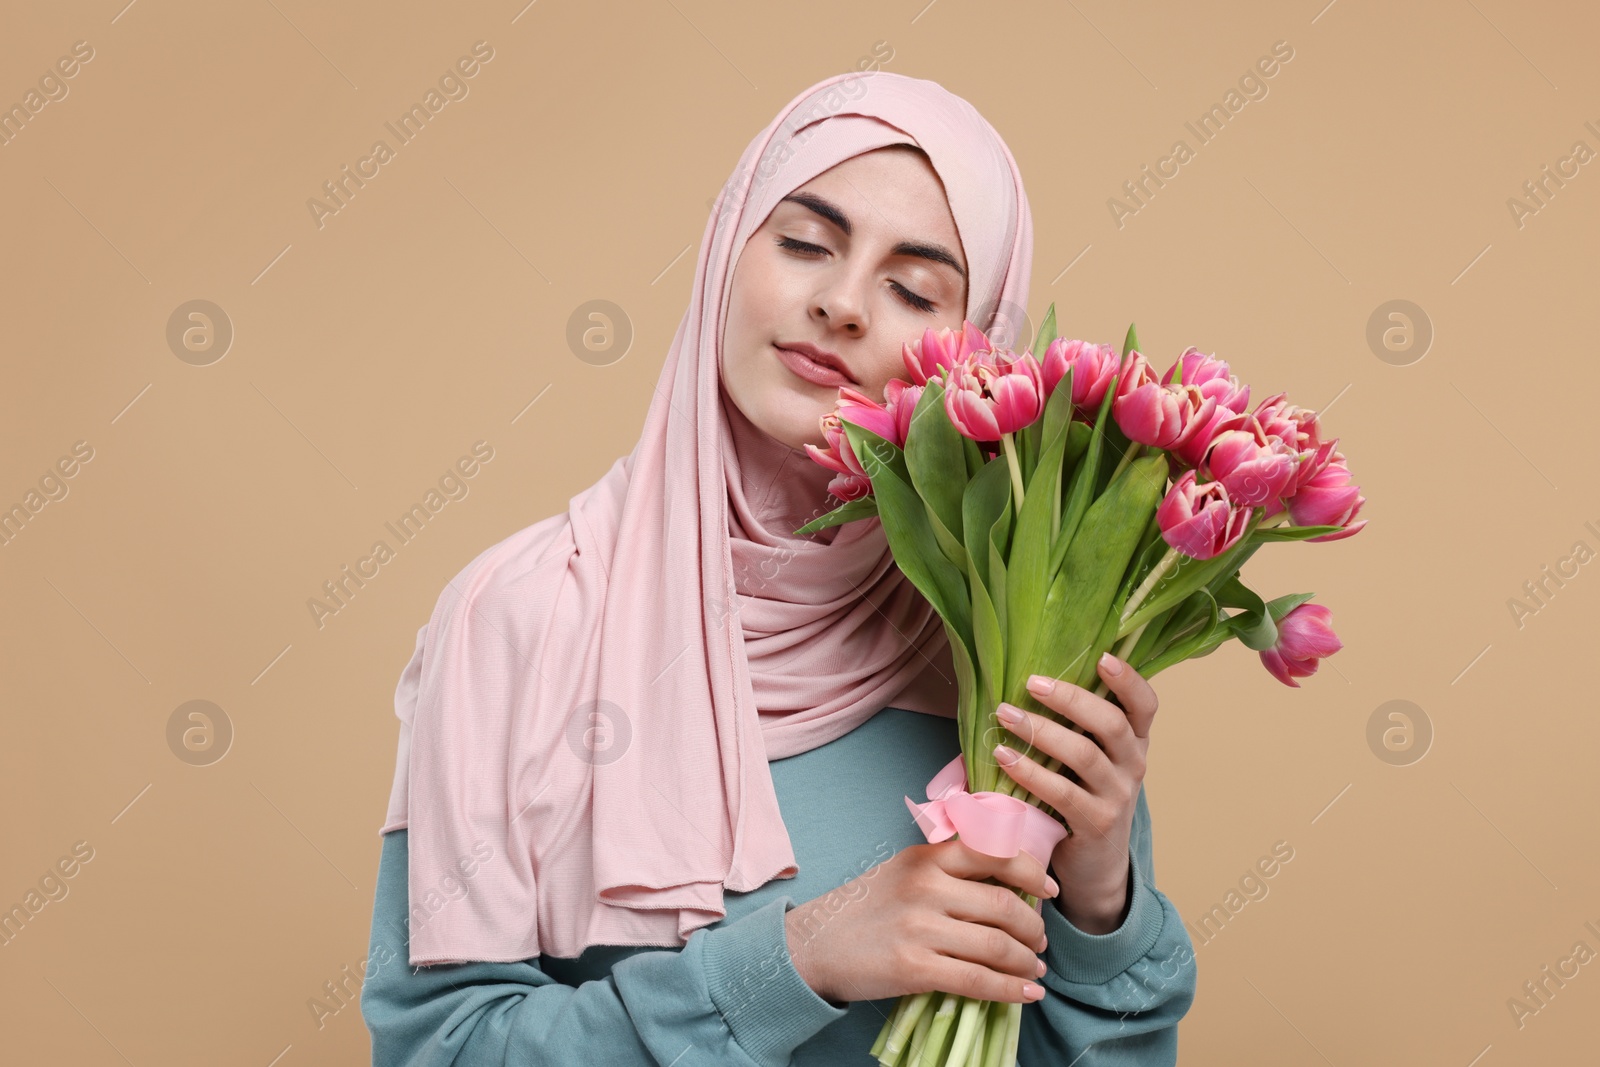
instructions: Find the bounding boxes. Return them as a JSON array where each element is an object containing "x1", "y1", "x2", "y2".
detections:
[{"x1": 362, "y1": 72, "x2": 1195, "y2": 1067}]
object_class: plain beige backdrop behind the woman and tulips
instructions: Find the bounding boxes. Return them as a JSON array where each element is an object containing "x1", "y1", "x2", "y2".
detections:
[{"x1": 0, "y1": 0, "x2": 1600, "y2": 1067}]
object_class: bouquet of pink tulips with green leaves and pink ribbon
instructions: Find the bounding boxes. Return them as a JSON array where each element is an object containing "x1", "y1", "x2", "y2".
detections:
[{"x1": 795, "y1": 306, "x2": 1366, "y2": 1067}]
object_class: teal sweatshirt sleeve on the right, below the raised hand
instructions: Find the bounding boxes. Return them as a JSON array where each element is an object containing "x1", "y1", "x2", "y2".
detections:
[{"x1": 1018, "y1": 785, "x2": 1197, "y2": 1067}]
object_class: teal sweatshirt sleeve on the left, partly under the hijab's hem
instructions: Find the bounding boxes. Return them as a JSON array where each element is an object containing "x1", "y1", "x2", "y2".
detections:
[{"x1": 362, "y1": 830, "x2": 848, "y2": 1067}]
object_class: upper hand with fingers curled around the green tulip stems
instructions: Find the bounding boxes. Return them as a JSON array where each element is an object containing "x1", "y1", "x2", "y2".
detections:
[{"x1": 995, "y1": 653, "x2": 1157, "y2": 934}]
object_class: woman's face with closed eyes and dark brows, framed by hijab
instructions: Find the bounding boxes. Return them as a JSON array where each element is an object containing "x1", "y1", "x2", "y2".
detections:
[{"x1": 722, "y1": 149, "x2": 966, "y2": 448}]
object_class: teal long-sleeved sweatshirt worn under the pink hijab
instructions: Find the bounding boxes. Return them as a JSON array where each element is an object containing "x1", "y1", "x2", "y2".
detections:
[{"x1": 362, "y1": 707, "x2": 1195, "y2": 1067}]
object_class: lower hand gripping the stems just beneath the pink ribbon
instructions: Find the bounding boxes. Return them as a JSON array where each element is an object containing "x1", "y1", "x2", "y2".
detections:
[{"x1": 784, "y1": 838, "x2": 1056, "y2": 1003}]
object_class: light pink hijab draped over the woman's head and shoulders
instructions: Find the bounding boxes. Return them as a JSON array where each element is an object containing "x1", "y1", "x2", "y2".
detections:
[{"x1": 381, "y1": 72, "x2": 1034, "y2": 966}]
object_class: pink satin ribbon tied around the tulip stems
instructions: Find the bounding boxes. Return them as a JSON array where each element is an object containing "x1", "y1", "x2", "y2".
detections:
[{"x1": 906, "y1": 755, "x2": 1067, "y2": 912}]
